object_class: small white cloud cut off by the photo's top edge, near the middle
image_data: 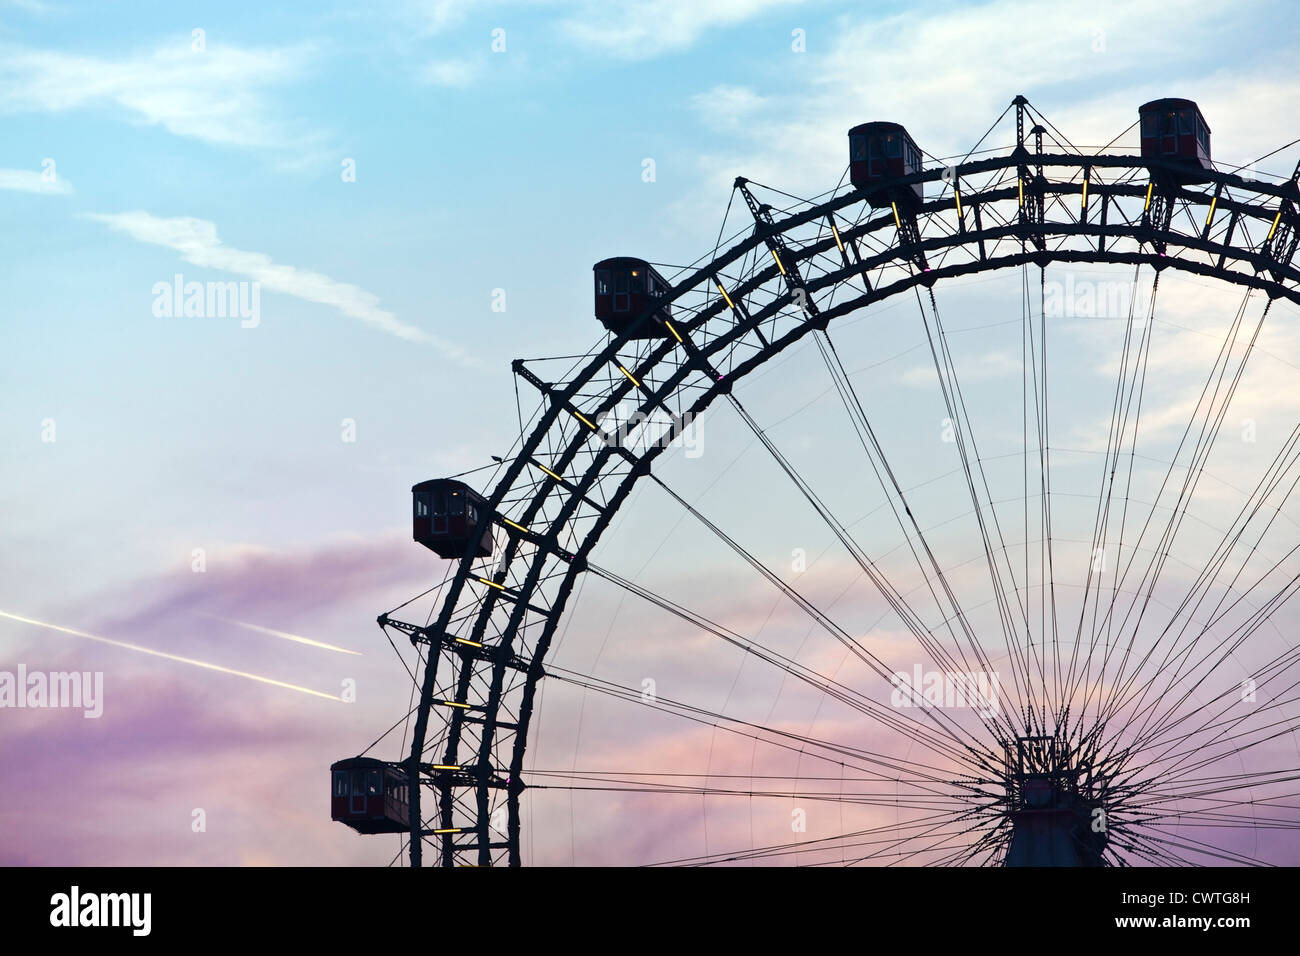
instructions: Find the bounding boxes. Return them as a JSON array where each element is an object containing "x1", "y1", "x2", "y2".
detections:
[{"x1": 559, "y1": 0, "x2": 798, "y2": 60}]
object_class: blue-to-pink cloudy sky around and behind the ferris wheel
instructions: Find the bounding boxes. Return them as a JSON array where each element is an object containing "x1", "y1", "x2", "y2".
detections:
[{"x1": 0, "y1": 0, "x2": 1300, "y2": 865}]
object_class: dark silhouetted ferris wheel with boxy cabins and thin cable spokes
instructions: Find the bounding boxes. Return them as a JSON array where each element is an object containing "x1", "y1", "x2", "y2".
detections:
[{"x1": 332, "y1": 96, "x2": 1300, "y2": 866}]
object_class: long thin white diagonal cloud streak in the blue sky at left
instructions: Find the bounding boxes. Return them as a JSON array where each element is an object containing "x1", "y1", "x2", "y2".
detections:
[{"x1": 87, "y1": 211, "x2": 468, "y2": 363}]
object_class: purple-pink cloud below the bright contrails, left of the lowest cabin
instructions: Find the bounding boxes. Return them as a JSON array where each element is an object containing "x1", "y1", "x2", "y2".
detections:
[{"x1": 0, "y1": 671, "x2": 374, "y2": 866}]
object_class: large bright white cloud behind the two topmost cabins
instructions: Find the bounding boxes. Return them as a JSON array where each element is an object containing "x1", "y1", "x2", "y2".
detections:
[{"x1": 670, "y1": 0, "x2": 1300, "y2": 209}]
